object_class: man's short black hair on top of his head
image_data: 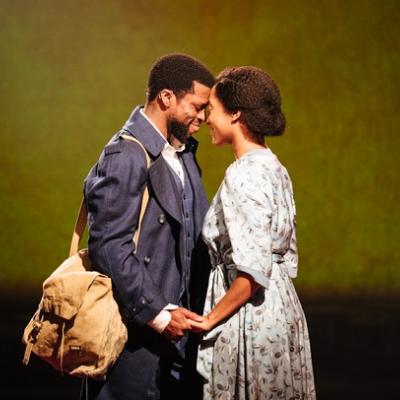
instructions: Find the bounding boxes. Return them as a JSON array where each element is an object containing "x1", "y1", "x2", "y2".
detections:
[{"x1": 147, "y1": 53, "x2": 215, "y2": 101}]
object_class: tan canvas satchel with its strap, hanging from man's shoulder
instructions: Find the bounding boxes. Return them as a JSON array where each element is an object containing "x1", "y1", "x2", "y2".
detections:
[{"x1": 22, "y1": 135, "x2": 150, "y2": 380}]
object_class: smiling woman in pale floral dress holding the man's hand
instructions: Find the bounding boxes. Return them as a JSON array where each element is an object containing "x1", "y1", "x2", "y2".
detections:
[{"x1": 192, "y1": 67, "x2": 315, "y2": 399}]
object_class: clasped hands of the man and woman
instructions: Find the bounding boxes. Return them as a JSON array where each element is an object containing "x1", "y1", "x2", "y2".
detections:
[{"x1": 163, "y1": 307, "x2": 214, "y2": 341}]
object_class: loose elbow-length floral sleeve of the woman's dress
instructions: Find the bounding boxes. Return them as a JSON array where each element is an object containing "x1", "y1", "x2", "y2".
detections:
[{"x1": 221, "y1": 164, "x2": 273, "y2": 287}]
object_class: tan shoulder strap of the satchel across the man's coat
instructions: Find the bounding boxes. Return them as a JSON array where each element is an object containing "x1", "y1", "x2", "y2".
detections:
[{"x1": 69, "y1": 134, "x2": 151, "y2": 257}]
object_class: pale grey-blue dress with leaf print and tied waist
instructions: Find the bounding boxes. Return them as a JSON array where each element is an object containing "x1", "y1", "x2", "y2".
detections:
[{"x1": 197, "y1": 149, "x2": 316, "y2": 400}]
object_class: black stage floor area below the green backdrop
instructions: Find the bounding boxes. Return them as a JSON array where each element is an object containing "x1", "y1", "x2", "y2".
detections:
[{"x1": 0, "y1": 296, "x2": 400, "y2": 400}]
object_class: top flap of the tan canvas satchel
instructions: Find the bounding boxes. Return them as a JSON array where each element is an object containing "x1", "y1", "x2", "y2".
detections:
[{"x1": 42, "y1": 271, "x2": 101, "y2": 320}]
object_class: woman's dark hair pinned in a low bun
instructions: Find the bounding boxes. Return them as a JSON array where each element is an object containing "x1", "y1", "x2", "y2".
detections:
[{"x1": 215, "y1": 66, "x2": 286, "y2": 143}]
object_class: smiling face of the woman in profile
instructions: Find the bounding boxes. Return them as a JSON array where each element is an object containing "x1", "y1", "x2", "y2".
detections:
[{"x1": 207, "y1": 86, "x2": 232, "y2": 146}]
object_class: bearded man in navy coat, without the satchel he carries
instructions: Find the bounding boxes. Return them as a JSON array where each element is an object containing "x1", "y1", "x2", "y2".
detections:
[{"x1": 82, "y1": 54, "x2": 214, "y2": 400}]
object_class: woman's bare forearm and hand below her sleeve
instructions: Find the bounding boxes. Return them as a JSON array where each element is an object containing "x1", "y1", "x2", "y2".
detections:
[{"x1": 190, "y1": 271, "x2": 260, "y2": 332}]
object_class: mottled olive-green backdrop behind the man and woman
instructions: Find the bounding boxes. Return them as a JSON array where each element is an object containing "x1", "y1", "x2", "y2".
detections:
[{"x1": 0, "y1": 0, "x2": 400, "y2": 295}]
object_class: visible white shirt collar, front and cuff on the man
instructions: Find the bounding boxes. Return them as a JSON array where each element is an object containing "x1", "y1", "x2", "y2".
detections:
[{"x1": 140, "y1": 108, "x2": 185, "y2": 333}]
